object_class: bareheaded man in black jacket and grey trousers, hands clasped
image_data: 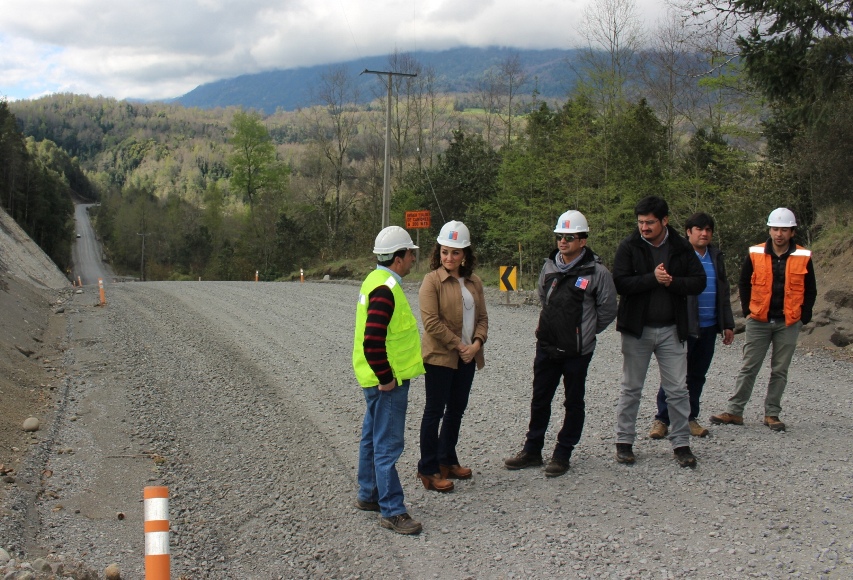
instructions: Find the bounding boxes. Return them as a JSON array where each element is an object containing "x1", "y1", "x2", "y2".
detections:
[{"x1": 613, "y1": 196, "x2": 706, "y2": 467}]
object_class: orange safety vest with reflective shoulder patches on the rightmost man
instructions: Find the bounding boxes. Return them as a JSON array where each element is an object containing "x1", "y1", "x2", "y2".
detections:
[{"x1": 749, "y1": 244, "x2": 812, "y2": 326}]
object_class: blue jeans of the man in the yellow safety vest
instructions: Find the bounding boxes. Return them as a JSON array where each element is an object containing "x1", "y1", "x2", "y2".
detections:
[{"x1": 358, "y1": 381, "x2": 409, "y2": 518}]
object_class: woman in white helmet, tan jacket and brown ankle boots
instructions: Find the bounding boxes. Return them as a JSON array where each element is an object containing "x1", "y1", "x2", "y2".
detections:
[{"x1": 418, "y1": 221, "x2": 489, "y2": 491}]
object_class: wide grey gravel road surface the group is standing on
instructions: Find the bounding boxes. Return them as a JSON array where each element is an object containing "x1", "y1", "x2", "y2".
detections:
[{"x1": 10, "y1": 282, "x2": 853, "y2": 579}]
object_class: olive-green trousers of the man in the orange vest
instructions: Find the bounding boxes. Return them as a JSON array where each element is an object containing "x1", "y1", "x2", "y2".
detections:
[{"x1": 729, "y1": 318, "x2": 803, "y2": 417}]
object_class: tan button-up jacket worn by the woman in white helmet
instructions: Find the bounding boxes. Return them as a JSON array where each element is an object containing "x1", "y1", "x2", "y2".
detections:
[{"x1": 418, "y1": 268, "x2": 489, "y2": 369}]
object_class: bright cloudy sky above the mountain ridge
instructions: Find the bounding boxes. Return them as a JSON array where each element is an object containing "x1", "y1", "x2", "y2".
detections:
[{"x1": 0, "y1": 0, "x2": 662, "y2": 100}]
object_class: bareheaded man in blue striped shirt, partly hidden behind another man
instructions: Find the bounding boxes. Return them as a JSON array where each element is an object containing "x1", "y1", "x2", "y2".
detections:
[{"x1": 649, "y1": 212, "x2": 735, "y2": 439}]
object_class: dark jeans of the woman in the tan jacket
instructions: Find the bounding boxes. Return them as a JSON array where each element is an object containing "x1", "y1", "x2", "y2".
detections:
[{"x1": 418, "y1": 360, "x2": 477, "y2": 475}]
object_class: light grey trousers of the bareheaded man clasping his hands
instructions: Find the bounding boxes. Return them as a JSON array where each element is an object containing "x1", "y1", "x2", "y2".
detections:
[{"x1": 616, "y1": 325, "x2": 690, "y2": 449}]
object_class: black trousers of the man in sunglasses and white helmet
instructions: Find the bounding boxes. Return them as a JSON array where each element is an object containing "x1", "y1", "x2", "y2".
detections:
[{"x1": 524, "y1": 344, "x2": 592, "y2": 460}]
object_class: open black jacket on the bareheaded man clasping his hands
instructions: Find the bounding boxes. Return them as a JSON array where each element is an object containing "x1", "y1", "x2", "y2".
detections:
[{"x1": 613, "y1": 226, "x2": 706, "y2": 341}]
